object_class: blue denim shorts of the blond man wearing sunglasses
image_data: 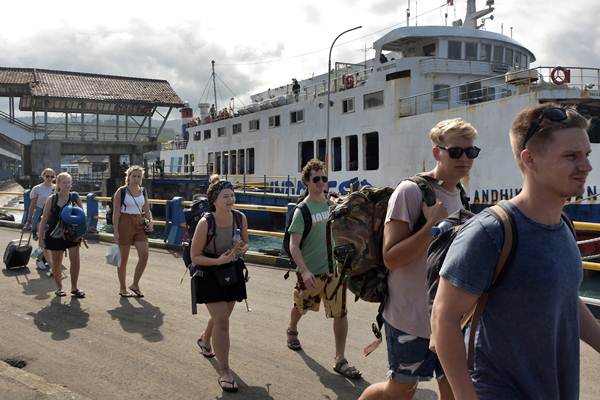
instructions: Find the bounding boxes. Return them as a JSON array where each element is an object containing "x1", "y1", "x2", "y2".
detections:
[{"x1": 385, "y1": 322, "x2": 444, "y2": 383}]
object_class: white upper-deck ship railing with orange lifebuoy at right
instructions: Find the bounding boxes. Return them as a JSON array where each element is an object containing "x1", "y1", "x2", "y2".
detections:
[{"x1": 398, "y1": 67, "x2": 600, "y2": 118}]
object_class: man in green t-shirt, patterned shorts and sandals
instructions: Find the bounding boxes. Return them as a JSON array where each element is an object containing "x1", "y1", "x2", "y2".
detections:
[{"x1": 287, "y1": 159, "x2": 361, "y2": 379}]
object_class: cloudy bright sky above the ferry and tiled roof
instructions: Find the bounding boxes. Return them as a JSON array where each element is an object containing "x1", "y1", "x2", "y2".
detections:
[{"x1": 0, "y1": 0, "x2": 600, "y2": 115}]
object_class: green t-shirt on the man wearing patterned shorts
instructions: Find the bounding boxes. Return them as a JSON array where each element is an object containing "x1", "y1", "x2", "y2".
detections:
[{"x1": 289, "y1": 198, "x2": 329, "y2": 275}]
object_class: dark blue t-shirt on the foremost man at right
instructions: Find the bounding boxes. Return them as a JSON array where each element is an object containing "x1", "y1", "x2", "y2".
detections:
[{"x1": 440, "y1": 201, "x2": 583, "y2": 400}]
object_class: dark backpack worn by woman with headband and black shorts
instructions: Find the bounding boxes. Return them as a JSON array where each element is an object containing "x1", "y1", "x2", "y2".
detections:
[{"x1": 181, "y1": 197, "x2": 243, "y2": 268}]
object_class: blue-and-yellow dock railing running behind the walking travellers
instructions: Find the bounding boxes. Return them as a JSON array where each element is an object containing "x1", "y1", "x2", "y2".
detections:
[{"x1": 0, "y1": 189, "x2": 600, "y2": 271}]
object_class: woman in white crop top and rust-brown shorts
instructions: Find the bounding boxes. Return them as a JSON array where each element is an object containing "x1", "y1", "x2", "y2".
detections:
[{"x1": 112, "y1": 165, "x2": 154, "y2": 297}]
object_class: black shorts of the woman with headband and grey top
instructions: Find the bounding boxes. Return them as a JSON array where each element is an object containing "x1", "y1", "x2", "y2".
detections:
[{"x1": 192, "y1": 259, "x2": 247, "y2": 304}]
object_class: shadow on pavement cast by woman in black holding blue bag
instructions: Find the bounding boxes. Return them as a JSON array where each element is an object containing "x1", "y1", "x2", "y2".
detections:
[{"x1": 27, "y1": 297, "x2": 90, "y2": 340}]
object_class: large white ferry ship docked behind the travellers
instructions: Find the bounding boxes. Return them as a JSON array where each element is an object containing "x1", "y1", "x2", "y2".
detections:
[{"x1": 160, "y1": 0, "x2": 600, "y2": 222}]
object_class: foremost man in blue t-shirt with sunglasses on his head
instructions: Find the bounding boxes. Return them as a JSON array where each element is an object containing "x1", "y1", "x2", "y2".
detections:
[{"x1": 431, "y1": 104, "x2": 600, "y2": 400}]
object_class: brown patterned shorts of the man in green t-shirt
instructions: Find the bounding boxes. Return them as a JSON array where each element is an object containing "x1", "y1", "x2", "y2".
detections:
[{"x1": 294, "y1": 273, "x2": 347, "y2": 318}]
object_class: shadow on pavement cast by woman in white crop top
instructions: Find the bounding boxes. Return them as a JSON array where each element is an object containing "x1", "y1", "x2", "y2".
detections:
[{"x1": 107, "y1": 297, "x2": 165, "y2": 342}]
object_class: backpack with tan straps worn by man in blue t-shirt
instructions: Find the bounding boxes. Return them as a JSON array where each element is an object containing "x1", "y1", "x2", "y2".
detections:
[{"x1": 427, "y1": 204, "x2": 576, "y2": 370}]
